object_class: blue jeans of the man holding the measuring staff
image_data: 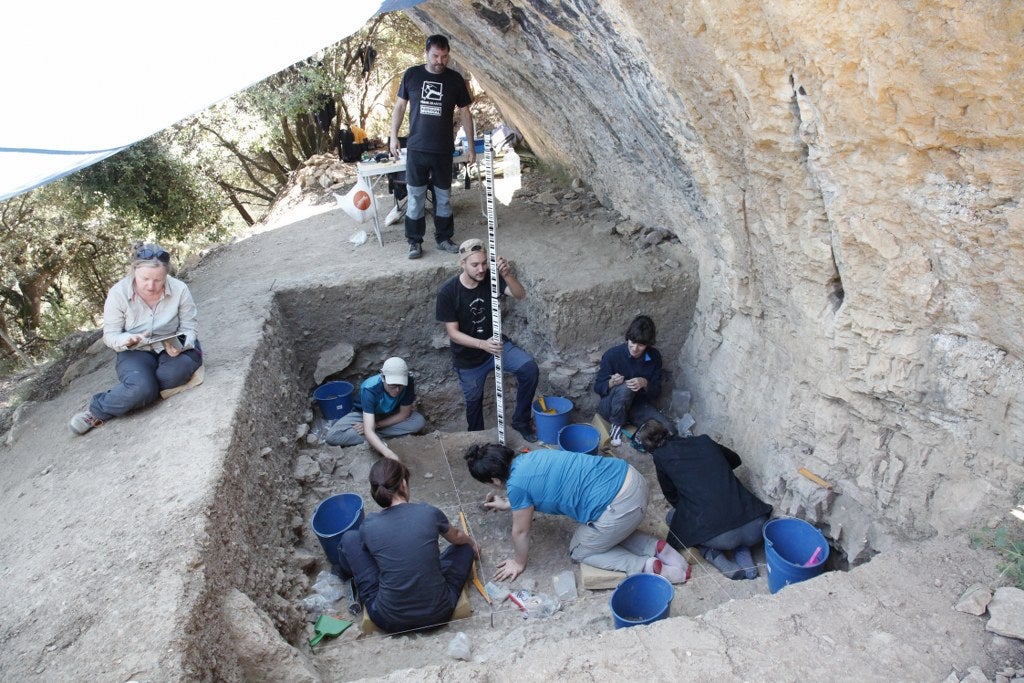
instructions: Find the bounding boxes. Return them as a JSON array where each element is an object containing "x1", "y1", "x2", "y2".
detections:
[{"x1": 455, "y1": 340, "x2": 541, "y2": 433}]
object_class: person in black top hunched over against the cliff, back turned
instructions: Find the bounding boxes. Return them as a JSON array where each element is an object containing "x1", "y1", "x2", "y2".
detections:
[{"x1": 634, "y1": 420, "x2": 771, "y2": 580}]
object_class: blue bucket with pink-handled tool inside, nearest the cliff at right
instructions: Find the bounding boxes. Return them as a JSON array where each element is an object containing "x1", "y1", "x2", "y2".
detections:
[{"x1": 762, "y1": 517, "x2": 828, "y2": 593}]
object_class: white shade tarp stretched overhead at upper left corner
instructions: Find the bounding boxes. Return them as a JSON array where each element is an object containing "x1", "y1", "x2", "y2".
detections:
[{"x1": 0, "y1": 0, "x2": 422, "y2": 200}]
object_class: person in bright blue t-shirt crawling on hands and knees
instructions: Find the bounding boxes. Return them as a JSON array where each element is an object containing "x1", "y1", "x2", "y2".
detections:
[{"x1": 465, "y1": 443, "x2": 689, "y2": 584}]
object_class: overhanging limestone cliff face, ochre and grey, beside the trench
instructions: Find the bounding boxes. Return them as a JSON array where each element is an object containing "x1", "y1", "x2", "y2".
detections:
[{"x1": 412, "y1": 0, "x2": 1024, "y2": 559}]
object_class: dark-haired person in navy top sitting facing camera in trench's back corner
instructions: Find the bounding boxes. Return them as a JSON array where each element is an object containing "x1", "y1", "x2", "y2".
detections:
[{"x1": 594, "y1": 315, "x2": 675, "y2": 445}]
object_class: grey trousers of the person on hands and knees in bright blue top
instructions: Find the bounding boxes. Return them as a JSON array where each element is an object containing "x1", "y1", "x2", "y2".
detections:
[{"x1": 569, "y1": 465, "x2": 657, "y2": 574}]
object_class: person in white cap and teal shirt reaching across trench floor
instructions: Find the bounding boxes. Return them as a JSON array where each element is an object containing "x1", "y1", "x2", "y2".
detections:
[{"x1": 325, "y1": 356, "x2": 427, "y2": 460}]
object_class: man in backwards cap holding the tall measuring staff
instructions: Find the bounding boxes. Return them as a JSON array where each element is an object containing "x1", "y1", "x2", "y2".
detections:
[{"x1": 435, "y1": 240, "x2": 541, "y2": 443}]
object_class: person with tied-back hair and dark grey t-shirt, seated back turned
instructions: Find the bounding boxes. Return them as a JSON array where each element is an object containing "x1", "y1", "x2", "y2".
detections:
[{"x1": 339, "y1": 459, "x2": 480, "y2": 633}]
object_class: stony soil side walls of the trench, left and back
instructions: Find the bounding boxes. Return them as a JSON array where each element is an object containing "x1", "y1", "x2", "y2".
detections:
[{"x1": 179, "y1": 268, "x2": 697, "y2": 681}]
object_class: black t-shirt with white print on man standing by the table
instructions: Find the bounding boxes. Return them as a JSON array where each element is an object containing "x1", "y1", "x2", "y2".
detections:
[{"x1": 398, "y1": 65, "x2": 473, "y2": 155}]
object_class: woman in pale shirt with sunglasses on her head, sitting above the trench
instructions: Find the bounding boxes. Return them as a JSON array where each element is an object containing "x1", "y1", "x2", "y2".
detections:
[{"x1": 68, "y1": 244, "x2": 203, "y2": 434}]
